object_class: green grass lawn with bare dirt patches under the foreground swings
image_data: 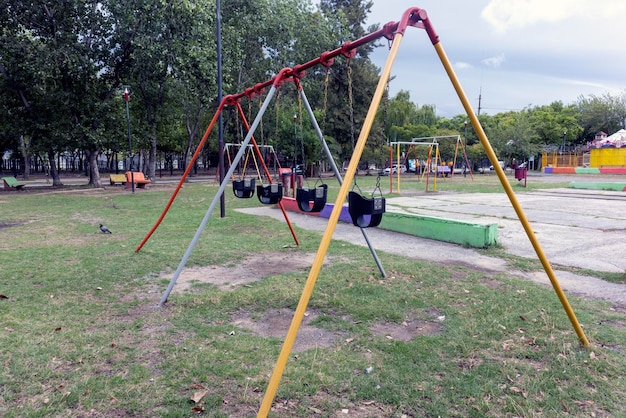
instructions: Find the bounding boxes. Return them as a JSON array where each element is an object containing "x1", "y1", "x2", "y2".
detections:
[{"x1": 0, "y1": 175, "x2": 626, "y2": 417}]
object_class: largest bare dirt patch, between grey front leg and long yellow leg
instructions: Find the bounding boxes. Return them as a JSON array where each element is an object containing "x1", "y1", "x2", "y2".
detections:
[{"x1": 160, "y1": 252, "x2": 322, "y2": 293}]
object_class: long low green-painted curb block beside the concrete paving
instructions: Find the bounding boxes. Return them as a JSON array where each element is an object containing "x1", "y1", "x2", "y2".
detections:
[{"x1": 380, "y1": 212, "x2": 498, "y2": 248}]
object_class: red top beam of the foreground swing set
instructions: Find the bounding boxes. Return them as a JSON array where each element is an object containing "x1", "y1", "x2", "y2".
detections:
[{"x1": 224, "y1": 7, "x2": 439, "y2": 105}]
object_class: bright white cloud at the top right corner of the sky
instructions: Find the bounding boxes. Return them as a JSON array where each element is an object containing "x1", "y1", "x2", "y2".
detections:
[{"x1": 481, "y1": 0, "x2": 626, "y2": 32}]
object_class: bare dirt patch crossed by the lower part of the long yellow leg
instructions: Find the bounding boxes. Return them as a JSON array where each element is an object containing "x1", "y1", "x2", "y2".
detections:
[{"x1": 232, "y1": 308, "x2": 344, "y2": 352}]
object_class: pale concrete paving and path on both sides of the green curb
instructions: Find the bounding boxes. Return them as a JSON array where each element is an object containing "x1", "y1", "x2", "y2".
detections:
[{"x1": 242, "y1": 189, "x2": 626, "y2": 307}]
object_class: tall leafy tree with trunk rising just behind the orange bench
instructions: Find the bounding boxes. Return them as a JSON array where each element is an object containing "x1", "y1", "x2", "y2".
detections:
[{"x1": 117, "y1": 1, "x2": 215, "y2": 178}]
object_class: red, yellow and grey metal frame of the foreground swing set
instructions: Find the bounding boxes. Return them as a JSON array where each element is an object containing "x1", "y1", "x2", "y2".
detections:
[{"x1": 130, "y1": 7, "x2": 589, "y2": 417}]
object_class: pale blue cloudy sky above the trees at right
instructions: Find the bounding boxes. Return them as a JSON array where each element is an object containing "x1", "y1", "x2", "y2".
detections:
[{"x1": 360, "y1": 0, "x2": 626, "y2": 117}]
